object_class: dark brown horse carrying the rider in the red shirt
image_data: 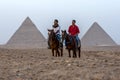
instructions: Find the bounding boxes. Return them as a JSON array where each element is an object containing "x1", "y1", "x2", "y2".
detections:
[{"x1": 62, "y1": 30, "x2": 81, "y2": 58}]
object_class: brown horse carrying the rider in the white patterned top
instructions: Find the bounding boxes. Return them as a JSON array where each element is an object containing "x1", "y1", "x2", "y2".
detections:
[{"x1": 48, "y1": 30, "x2": 63, "y2": 57}]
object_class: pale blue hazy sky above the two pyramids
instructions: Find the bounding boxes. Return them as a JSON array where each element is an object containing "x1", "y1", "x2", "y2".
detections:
[{"x1": 0, "y1": 0, "x2": 120, "y2": 44}]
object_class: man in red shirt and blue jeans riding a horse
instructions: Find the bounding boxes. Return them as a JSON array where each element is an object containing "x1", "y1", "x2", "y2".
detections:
[{"x1": 68, "y1": 20, "x2": 80, "y2": 48}]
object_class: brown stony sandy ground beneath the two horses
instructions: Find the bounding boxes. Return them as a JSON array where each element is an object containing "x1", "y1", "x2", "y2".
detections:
[{"x1": 0, "y1": 49, "x2": 120, "y2": 80}]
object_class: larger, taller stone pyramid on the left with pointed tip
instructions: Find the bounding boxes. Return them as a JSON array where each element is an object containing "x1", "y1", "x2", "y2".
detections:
[{"x1": 7, "y1": 17, "x2": 46, "y2": 48}]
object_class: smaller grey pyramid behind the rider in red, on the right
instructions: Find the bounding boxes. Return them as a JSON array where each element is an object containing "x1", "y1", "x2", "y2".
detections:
[{"x1": 81, "y1": 22, "x2": 117, "y2": 46}]
